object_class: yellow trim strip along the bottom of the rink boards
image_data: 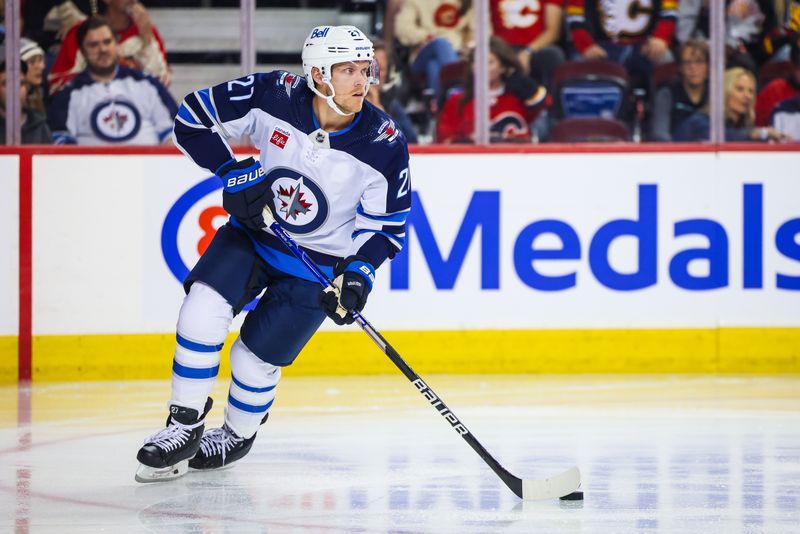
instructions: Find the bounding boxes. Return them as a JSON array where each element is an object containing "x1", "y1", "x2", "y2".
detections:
[{"x1": 0, "y1": 328, "x2": 800, "y2": 382}]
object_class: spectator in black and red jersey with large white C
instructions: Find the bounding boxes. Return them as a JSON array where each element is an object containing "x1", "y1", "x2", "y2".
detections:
[{"x1": 567, "y1": 0, "x2": 678, "y2": 87}]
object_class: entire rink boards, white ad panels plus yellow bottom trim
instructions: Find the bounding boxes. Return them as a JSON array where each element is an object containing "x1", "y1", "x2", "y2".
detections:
[{"x1": 0, "y1": 149, "x2": 800, "y2": 380}]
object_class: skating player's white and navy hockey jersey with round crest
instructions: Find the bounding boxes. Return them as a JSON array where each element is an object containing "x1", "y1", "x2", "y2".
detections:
[{"x1": 174, "y1": 71, "x2": 411, "y2": 281}]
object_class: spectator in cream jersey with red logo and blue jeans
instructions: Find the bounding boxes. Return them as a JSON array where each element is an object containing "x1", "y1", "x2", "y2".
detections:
[{"x1": 394, "y1": 0, "x2": 473, "y2": 97}]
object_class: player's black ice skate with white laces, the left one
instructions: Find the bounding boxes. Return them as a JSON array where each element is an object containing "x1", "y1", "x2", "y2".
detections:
[{"x1": 136, "y1": 397, "x2": 213, "y2": 482}]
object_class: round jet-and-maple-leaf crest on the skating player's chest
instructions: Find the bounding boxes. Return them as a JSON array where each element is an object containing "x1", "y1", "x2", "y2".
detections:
[{"x1": 266, "y1": 167, "x2": 328, "y2": 234}]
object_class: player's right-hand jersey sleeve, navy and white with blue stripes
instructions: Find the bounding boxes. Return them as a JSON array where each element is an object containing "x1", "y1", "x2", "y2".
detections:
[{"x1": 349, "y1": 140, "x2": 411, "y2": 269}]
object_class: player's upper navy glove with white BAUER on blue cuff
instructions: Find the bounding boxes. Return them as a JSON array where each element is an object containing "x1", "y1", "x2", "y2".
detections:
[{"x1": 217, "y1": 157, "x2": 272, "y2": 230}]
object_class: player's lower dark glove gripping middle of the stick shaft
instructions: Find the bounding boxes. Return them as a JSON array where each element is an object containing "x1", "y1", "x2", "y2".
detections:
[{"x1": 319, "y1": 256, "x2": 375, "y2": 325}]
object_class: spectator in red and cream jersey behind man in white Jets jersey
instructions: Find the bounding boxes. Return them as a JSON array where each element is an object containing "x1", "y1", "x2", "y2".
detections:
[{"x1": 48, "y1": 0, "x2": 171, "y2": 95}]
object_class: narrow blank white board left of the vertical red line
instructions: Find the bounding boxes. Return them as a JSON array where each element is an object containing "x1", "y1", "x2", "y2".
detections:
[{"x1": 0, "y1": 156, "x2": 19, "y2": 336}]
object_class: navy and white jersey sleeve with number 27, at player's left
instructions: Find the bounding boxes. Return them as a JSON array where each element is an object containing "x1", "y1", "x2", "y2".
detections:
[{"x1": 173, "y1": 72, "x2": 280, "y2": 173}]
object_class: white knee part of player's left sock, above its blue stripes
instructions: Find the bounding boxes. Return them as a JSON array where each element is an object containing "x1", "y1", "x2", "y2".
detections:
[{"x1": 178, "y1": 282, "x2": 233, "y2": 345}]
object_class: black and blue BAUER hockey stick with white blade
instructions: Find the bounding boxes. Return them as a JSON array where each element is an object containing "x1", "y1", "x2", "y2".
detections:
[{"x1": 263, "y1": 206, "x2": 582, "y2": 501}]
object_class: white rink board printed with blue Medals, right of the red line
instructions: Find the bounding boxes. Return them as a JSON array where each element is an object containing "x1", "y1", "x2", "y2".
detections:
[{"x1": 33, "y1": 152, "x2": 800, "y2": 334}]
